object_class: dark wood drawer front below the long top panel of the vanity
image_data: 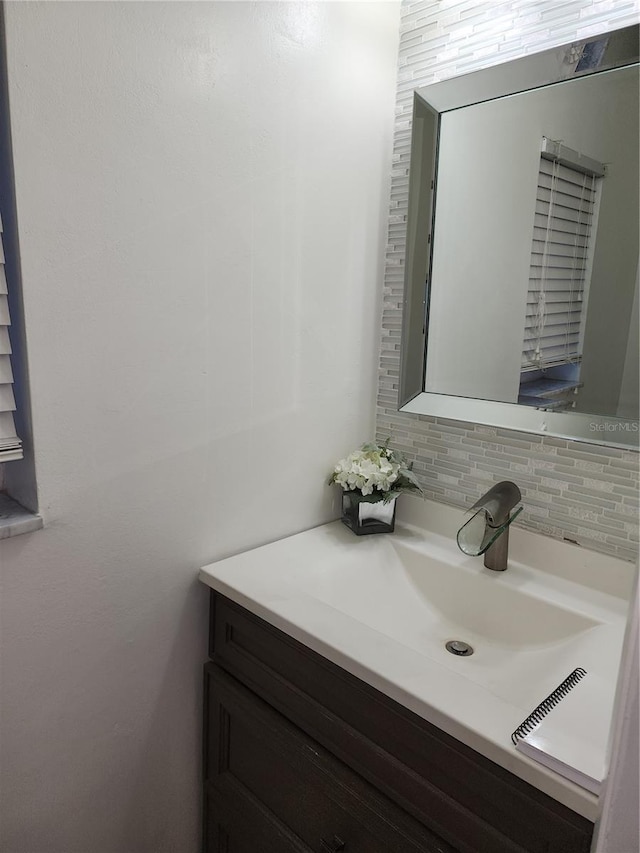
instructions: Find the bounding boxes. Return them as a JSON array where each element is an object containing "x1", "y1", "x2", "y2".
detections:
[{"x1": 205, "y1": 664, "x2": 454, "y2": 853}]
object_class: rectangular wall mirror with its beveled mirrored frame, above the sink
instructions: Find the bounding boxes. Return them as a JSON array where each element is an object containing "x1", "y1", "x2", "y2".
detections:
[{"x1": 399, "y1": 26, "x2": 640, "y2": 448}]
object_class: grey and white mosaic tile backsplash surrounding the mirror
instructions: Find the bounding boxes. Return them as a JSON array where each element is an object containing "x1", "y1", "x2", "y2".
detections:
[{"x1": 376, "y1": 0, "x2": 640, "y2": 561}]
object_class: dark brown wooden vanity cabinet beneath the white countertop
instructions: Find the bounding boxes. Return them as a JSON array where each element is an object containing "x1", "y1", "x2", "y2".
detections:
[{"x1": 204, "y1": 592, "x2": 593, "y2": 853}]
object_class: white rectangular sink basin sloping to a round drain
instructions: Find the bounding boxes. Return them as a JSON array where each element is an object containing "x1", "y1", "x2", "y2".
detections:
[{"x1": 294, "y1": 536, "x2": 608, "y2": 708}]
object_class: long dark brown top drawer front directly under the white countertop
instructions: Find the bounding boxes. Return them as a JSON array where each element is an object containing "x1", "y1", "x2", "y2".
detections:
[{"x1": 210, "y1": 593, "x2": 593, "y2": 853}]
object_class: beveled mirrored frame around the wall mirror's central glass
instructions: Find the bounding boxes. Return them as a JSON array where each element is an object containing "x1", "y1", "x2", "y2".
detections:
[{"x1": 398, "y1": 26, "x2": 640, "y2": 450}]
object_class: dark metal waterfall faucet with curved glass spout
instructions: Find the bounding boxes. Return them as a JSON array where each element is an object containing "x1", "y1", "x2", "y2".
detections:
[{"x1": 456, "y1": 480, "x2": 522, "y2": 572}]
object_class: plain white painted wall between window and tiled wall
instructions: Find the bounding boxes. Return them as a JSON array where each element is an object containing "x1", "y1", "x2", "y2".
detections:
[{"x1": 0, "y1": 2, "x2": 399, "y2": 853}]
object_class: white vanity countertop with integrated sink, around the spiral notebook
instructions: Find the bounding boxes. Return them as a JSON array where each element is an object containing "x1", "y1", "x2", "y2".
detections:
[{"x1": 200, "y1": 500, "x2": 634, "y2": 820}]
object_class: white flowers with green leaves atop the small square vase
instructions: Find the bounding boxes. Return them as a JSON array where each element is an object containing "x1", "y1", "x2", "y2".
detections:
[{"x1": 329, "y1": 439, "x2": 422, "y2": 503}]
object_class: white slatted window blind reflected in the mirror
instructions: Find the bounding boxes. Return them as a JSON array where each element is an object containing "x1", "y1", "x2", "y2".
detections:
[{"x1": 522, "y1": 138, "x2": 604, "y2": 371}]
